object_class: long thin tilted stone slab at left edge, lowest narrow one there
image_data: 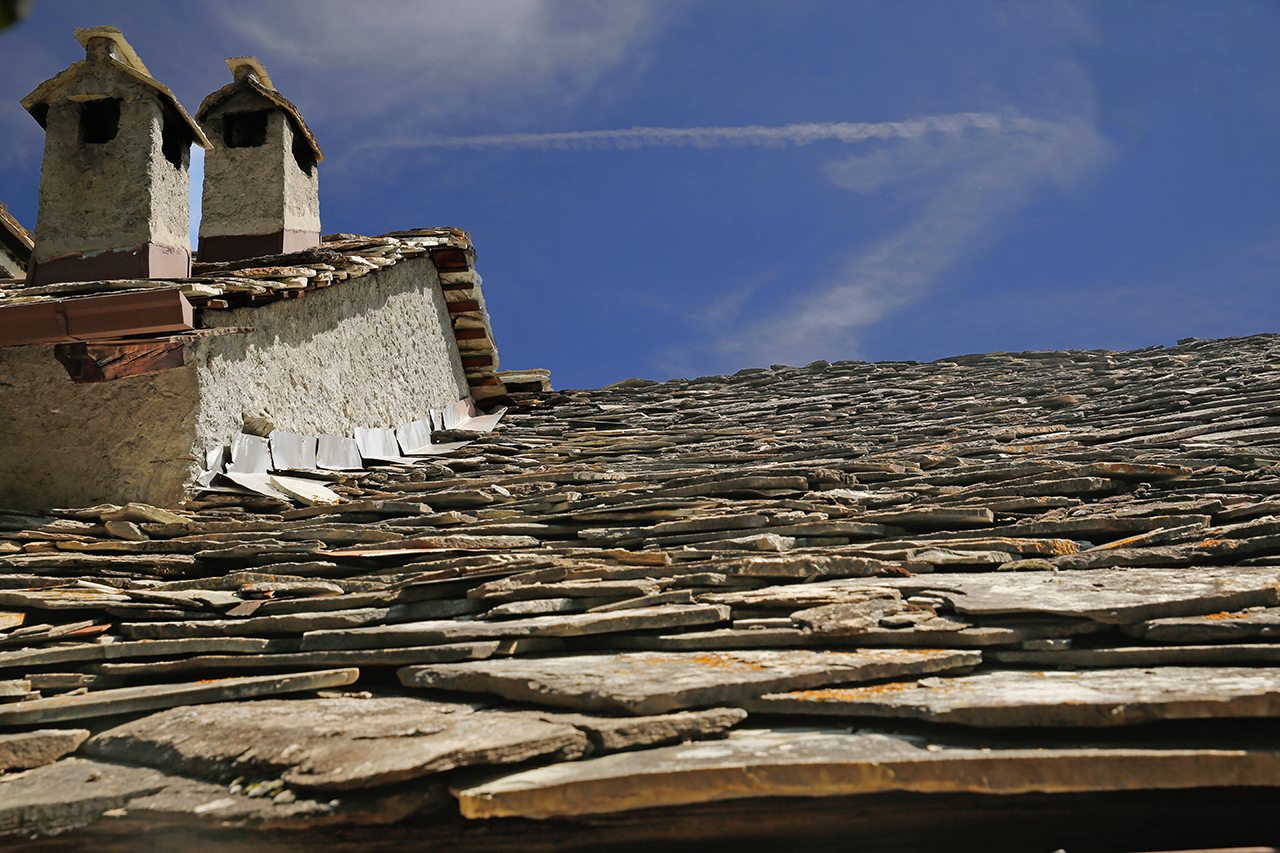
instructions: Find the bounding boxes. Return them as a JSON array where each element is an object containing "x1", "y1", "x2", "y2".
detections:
[{"x1": 0, "y1": 669, "x2": 360, "y2": 726}]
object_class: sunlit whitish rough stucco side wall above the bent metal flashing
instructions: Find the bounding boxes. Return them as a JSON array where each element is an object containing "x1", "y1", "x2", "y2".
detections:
[{"x1": 193, "y1": 257, "x2": 468, "y2": 450}]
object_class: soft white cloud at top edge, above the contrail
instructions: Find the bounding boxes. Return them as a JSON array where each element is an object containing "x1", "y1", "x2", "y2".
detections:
[{"x1": 207, "y1": 0, "x2": 671, "y2": 126}]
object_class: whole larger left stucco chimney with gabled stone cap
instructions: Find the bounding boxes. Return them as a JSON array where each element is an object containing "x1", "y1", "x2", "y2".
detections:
[{"x1": 22, "y1": 27, "x2": 209, "y2": 284}]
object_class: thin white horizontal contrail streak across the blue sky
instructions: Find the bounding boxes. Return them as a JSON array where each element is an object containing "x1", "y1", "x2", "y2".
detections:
[{"x1": 386, "y1": 113, "x2": 1042, "y2": 150}]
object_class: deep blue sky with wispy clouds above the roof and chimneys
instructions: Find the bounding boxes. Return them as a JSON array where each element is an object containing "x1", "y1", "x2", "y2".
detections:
[{"x1": 0, "y1": 0, "x2": 1280, "y2": 388}]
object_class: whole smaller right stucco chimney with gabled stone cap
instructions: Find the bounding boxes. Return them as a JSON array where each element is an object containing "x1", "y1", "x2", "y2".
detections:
[{"x1": 196, "y1": 56, "x2": 324, "y2": 261}]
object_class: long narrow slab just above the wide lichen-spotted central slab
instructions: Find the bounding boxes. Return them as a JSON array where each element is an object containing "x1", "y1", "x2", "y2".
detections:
[{"x1": 293, "y1": 605, "x2": 728, "y2": 651}]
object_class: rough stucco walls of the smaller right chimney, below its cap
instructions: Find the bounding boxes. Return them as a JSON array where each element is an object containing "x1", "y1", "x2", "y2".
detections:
[{"x1": 200, "y1": 108, "x2": 320, "y2": 237}]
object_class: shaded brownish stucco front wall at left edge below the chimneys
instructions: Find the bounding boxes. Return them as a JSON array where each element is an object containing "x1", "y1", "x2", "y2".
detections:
[{"x1": 0, "y1": 346, "x2": 198, "y2": 510}]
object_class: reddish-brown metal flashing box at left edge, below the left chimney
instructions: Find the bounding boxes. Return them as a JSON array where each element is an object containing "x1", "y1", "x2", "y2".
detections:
[{"x1": 0, "y1": 287, "x2": 195, "y2": 346}]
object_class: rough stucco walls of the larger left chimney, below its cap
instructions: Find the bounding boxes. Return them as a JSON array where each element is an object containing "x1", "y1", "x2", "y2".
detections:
[{"x1": 35, "y1": 68, "x2": 191, "y2": 260}]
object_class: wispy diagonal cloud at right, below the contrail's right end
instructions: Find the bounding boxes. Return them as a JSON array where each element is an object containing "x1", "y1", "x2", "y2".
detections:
[{"x1": 716, "y1": 119, "x2": 1112, "y2": 364}]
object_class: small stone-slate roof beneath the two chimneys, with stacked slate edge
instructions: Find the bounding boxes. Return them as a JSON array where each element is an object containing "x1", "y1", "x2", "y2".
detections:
[{"x1": 0, "y1": 228, "x2": 503, "y2": 401}]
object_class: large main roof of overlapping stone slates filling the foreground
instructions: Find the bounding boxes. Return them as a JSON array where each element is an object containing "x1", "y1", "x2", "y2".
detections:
[{"x1": 0, "y1": 330, "x2": 1280, "y2": 850}]
